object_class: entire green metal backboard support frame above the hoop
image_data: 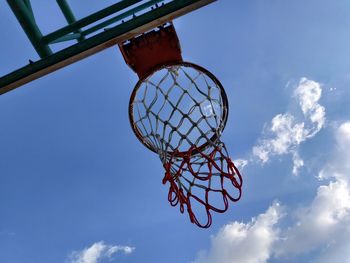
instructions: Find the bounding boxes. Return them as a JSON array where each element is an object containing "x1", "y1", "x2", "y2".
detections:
[{"x1": 0, "y1": 0, "x2": 216, "y2": 94}]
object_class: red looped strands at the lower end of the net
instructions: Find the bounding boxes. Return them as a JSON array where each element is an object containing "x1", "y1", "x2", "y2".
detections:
[{"x1": 163, "y1": 142, "x2": 242, "y2": 228}]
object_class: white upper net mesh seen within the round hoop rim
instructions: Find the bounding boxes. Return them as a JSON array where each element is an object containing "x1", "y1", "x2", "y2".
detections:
[{"x1": 130, "y1": 62, "x2": 227, "y2": 154}]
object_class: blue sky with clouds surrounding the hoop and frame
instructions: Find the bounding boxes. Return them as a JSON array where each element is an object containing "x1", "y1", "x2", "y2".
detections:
[{"x1": 0, "y1": 0, "x2": 350, "y2": 263}]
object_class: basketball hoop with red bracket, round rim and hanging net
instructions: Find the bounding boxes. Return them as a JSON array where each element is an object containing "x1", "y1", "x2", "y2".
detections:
[{"x1": 120, "y1": 23, "x2": 242, "y2": 228}]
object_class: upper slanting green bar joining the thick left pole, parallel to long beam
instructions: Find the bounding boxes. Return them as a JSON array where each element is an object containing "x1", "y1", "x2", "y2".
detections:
[{"x1": 43, "y1": 0, "x2": 142, "y2": 44}]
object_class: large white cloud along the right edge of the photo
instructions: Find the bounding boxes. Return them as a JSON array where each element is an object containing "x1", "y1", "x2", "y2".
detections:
[{"x1": 275, "y1": 122, "x2": 350, "y2": 262}]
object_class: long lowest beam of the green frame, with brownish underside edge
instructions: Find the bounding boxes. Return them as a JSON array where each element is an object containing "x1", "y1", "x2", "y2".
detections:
[{"x1": 0, "y1": 0, "x2": 216, "y2": 94}]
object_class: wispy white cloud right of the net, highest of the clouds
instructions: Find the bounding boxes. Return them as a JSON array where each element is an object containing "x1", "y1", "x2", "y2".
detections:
[{"x1": 253, "y1": 78, "x2": 325, "y2": 175}]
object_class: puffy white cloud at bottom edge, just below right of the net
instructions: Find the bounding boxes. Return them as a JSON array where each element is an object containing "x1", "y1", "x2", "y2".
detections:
[{"x1": 194, "y1": 202, "x2": 281, "y2": 263}]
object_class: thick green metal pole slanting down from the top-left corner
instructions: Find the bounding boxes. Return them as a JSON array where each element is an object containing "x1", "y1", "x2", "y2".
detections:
[{"x1": 7, "y1": 0, "x2": 52, "y2": 58}]
